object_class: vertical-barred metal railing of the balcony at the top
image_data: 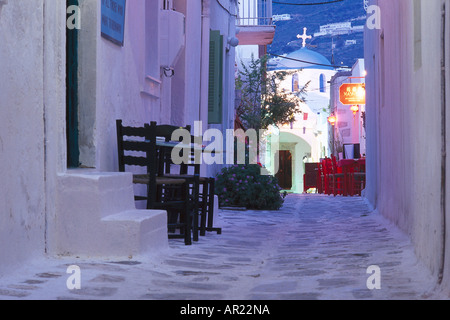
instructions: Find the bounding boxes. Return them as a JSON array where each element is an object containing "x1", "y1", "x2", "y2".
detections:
[{"x1": 237, "y1": 0, "x2": 273, "y2": 26}]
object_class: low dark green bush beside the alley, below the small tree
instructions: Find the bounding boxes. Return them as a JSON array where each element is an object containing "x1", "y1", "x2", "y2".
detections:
[{"x1": 216, "y1": 165, "x2": 286, "y2": 210}]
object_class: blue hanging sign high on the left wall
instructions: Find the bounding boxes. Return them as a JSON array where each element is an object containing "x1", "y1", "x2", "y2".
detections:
[{"x1": 101, "y1": 0, "x2": 126, "y2": 46}]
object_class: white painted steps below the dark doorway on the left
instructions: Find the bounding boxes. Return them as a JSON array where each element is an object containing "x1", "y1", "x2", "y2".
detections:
[{"x1": 52, "y1": 169, "x2": 168, "y2": 257}]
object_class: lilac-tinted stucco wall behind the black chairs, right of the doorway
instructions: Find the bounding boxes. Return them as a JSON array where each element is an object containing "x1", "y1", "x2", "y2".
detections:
[{"x1": 85, "y1": 0, "x2": 235, "y2": 175}]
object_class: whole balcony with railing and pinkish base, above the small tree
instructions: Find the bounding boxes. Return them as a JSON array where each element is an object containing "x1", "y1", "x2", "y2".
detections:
[{"x1": 236, "y1": 0, "x2": 275, "y2": 45}]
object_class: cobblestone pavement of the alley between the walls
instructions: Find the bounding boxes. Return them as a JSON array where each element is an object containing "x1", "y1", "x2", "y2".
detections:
[{"x1": 0, "y1": 195, "x2": 444, "y2": 300}]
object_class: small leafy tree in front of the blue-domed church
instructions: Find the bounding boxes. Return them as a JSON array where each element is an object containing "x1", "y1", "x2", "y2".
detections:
[{"x1": 236, "y1": 55, "x2": 309, "y2": 130}]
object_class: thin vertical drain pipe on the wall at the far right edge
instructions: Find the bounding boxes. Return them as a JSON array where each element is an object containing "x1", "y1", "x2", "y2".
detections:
[{"x1": 438, "y1": 3, "x2": 447, "y2": 284}]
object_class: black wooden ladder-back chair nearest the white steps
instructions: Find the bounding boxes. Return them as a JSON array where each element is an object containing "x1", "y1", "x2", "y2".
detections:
[{"x1": 116, "y1": 120, "x2": 193, "y2": 245}]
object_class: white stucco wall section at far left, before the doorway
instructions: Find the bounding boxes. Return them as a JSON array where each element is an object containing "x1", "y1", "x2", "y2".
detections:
[{"x1": 0, "y1": 0, "x2": 45, "y2": 274}]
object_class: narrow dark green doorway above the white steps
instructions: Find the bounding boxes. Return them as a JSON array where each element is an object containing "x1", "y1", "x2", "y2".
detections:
[{"x1": 66, "y1": 0, "x2": 80, "y2": 168}]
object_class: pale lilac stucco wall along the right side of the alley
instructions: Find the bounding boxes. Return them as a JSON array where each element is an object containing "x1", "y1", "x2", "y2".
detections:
[{"x1": 365, "y1": 0, "x2": 448, "y2": 284}]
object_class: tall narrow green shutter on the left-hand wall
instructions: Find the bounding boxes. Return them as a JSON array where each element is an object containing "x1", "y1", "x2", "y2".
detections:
[{"x1": 208, "y1": 30, "x2": 223, "y2": 124}]
